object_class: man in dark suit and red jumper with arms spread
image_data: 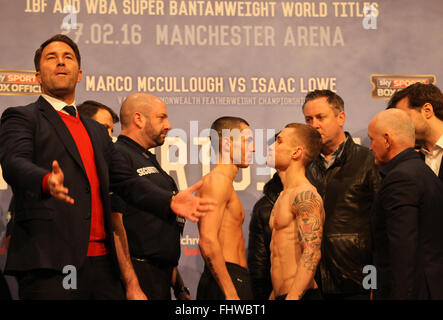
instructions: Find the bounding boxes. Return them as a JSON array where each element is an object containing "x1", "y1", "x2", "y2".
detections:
[{"x1": 0, "y1": 35, "x2": 213, "y2": 299}]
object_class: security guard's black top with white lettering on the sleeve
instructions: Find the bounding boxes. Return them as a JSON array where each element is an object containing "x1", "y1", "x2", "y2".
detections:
[{"x1": 111, "y1": 135, "x2": 184, "y2": 266}]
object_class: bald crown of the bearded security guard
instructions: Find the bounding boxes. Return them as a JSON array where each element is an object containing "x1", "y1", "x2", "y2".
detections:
[{"x1": 120, "y1": 93, "x2": 165, "y2": 130}]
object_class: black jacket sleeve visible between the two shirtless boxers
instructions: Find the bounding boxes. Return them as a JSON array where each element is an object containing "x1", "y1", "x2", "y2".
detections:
[{"x1": 248, "y1": 173, "x2": 283, "y2": 300}]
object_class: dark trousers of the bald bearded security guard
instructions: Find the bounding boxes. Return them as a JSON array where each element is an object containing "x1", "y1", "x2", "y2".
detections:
[{"x1": 132, "y1": 258, "x2": 174, "y2": 300}]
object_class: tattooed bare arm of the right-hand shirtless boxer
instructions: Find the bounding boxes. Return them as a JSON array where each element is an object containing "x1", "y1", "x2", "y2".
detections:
[{"x1": 286, "y1": 190, "x2": 324, "y2": 300}]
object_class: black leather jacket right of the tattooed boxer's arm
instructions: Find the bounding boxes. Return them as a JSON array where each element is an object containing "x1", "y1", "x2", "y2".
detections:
[{"x1": 306, "y1": 133, "x2": 380, "y2": 294}]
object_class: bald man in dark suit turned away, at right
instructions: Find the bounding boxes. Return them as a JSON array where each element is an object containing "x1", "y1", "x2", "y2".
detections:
[{"x1": 368, "y1": 109, "x2": 443, "y2": 299}]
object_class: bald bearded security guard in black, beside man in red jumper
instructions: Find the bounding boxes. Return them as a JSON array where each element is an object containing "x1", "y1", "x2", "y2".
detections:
[{"x1": 112, "y1": 93, "x2": 192, "y2": 300}]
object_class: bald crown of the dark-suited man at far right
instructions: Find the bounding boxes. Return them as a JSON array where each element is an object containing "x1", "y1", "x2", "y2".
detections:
[{"x1": 369, "y1": 109, "x2": 415, "y2": 148}]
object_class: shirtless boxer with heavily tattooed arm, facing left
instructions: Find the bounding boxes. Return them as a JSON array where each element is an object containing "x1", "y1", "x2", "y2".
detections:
[{"x1": 268, "y1": 124, "x2": 325, "y2": 300}]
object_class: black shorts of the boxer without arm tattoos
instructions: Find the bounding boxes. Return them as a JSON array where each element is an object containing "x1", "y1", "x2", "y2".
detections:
[{"x1": 197, "y1": 262, "x2": 253, "y2": 300}]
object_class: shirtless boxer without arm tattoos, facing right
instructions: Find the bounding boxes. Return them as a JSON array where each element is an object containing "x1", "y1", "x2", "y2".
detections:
[{"x1": 197, "y1": 117, "x2": 255, "y2": 300}]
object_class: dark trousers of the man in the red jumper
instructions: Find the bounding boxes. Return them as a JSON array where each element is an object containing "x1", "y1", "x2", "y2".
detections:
[{"x1": 17, "y1": 255, "x2": 126, "y2": 300}]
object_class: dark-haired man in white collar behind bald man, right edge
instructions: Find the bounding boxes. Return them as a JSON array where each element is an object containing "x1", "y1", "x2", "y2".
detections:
[{"x1": 388, "y1": 82, "x2": 443, "y2": 181}]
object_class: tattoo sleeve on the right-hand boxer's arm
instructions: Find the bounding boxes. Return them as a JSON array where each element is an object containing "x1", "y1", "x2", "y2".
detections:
[{"x1": 293, "y1": 191, "x2": 323, "y2": 272}]
